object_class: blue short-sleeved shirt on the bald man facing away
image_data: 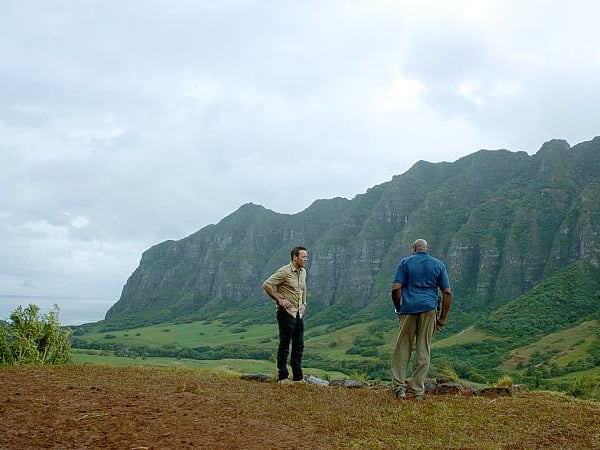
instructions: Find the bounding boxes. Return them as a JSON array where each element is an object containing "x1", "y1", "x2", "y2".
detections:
[{"x1": 394, "y1": 252, "x2": 450, "y2": 314}]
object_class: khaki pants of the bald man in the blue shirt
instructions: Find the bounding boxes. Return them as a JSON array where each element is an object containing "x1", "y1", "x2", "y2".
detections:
[{"x1": 392, "y1": 310, "x2": 436, "y2": 394}]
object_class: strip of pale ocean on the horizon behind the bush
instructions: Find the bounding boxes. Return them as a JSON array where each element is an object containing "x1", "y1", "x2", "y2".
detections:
[{"x1": 0, "y1": 295, "x2": 116, "y2": 325}]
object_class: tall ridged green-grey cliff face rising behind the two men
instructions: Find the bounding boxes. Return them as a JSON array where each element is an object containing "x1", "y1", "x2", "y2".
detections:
[{"x1": 107, "y1": 138, "x2": 600, "y2": 320}]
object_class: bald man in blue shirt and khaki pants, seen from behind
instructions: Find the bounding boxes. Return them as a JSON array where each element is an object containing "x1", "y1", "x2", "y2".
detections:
[{"x1": 392, "y1": 239, "x2": 452, "y2": 400}]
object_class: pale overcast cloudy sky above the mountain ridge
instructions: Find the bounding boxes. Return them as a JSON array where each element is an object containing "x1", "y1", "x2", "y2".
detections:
[{"x1": 0, "y1": 0, "x2": 600, "y2": 301}]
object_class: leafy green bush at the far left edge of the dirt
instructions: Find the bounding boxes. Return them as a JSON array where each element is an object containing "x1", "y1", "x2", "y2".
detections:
[{"x1": 0, "y1": 305, "x2": 71, "y2": 365}]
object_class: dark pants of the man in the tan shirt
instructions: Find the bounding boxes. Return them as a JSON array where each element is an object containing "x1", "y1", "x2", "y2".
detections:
[{"x1": 277, "y1": 309, "x2": 304, "y2": 381}]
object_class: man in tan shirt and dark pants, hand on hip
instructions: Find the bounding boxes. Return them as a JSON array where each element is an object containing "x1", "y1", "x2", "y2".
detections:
[{"x1": 263, "y1": 247, "x2": 308, "y2": 382}]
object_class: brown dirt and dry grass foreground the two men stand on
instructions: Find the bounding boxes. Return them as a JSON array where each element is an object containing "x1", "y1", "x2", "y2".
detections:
[{"x1": 0, "y1": 365, "x2": 600, "y2": 449}]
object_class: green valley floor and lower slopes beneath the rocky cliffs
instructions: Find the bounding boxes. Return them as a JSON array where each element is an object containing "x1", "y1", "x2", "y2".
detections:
[{"x1": 74, "y1": 262, "x2": 600, "y2": 396}]
